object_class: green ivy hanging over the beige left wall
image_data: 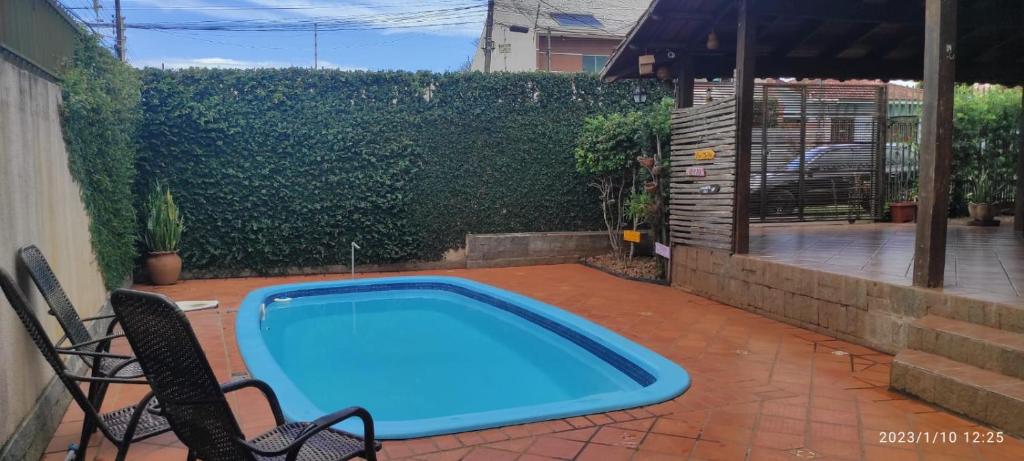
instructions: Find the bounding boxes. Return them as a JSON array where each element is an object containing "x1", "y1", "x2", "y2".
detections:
[{"x1": 60, "y1": 33, "x2": 141, "y2": 289}]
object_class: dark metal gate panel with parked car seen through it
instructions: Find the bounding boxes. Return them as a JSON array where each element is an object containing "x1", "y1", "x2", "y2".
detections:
[{"x1": 751, "y1": 83, "x2": 886, "y2": 222}]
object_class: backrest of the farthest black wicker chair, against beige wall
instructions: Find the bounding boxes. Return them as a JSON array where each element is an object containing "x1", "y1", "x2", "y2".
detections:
[{"x1": 17, "y1": 245, "x2": 95, "y2": 350}]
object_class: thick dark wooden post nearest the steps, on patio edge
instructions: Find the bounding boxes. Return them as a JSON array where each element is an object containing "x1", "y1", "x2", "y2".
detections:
[{"x1": 913, "y1": 0, "x2": 956, "y2": 288}]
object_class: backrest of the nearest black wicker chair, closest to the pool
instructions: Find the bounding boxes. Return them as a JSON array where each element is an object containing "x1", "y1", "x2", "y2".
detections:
[{"x1": 111, "y1": 290, "x2": 254, "y2": 461}]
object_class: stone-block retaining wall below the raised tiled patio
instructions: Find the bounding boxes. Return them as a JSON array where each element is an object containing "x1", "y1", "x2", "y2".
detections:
[{"x1": 672, "y1": 245, "x2": 1024, "y2": 353}]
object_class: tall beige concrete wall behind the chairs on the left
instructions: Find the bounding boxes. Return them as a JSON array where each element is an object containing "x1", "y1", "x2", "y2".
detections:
[{"x1": 0, "y1": 50, "x2": 105, "y2": 459}]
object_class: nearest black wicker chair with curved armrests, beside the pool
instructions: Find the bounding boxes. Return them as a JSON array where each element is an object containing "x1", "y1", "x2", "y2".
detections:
[{"x1": 111, "y1": 290, "x2": 380, "y2": 461}]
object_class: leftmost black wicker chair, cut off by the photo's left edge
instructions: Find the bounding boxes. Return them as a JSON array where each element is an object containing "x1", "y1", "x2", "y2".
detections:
[{"x1": 0, "y1": 269, "x2": 171, "y2": 461}]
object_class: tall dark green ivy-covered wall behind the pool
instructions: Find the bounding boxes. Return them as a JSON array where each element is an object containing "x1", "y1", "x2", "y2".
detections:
[{"x1": 136, "y1": 69, "x2": 665, "y2": 273}]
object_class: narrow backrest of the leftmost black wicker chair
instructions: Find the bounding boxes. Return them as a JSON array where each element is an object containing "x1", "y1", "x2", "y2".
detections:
[{"x1": 0, "y1": 269, "x2": 102, "y2": 428}]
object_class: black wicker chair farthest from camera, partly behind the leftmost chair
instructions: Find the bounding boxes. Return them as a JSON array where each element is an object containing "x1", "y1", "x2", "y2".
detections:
[{"x1": 17, "y1": 245, "x2": 148, "y2": 450}]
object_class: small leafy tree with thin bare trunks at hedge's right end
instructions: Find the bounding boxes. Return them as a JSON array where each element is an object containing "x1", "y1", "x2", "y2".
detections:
[{"x1": 575, "y1": 113, "x2": 645, "y2": 256}]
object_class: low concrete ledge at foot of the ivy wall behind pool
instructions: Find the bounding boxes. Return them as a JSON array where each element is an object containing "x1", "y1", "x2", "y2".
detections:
[{"x1": 466, "y1": 232, "x2": 611, "y2": 268}]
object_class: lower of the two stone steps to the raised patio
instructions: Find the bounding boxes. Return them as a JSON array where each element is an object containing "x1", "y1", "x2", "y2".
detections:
[{"x1": 890, "y1": 349, "x2": 1024, "y2": 435}]
